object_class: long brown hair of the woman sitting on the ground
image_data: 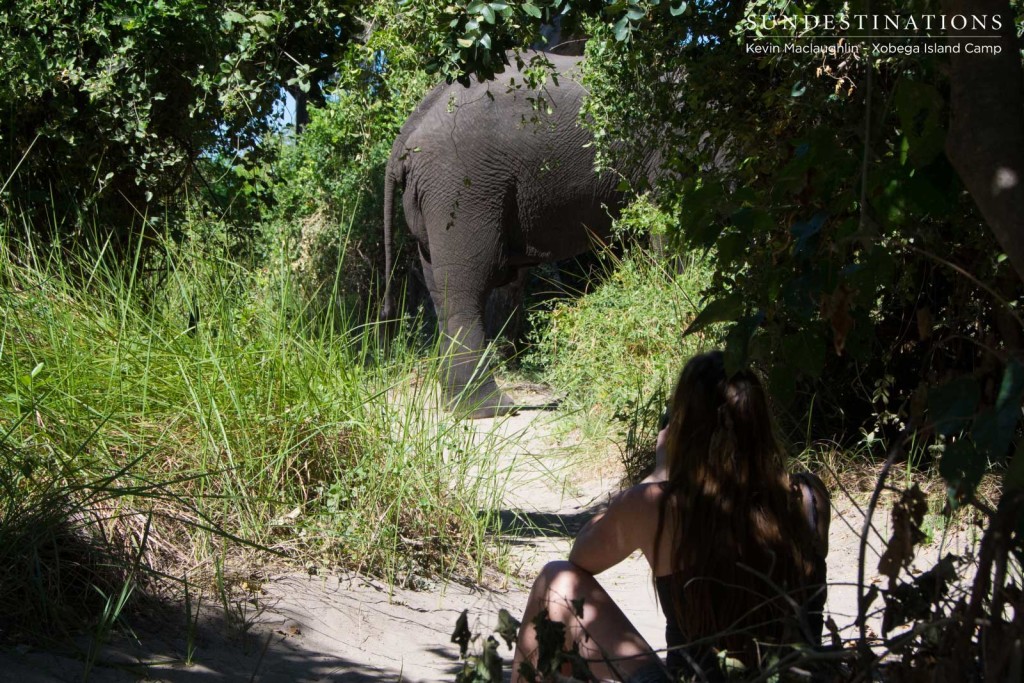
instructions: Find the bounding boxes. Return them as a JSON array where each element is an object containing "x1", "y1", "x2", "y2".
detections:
[{"x1": 654, "y1": 351, "x2": 815, "y2": 666}]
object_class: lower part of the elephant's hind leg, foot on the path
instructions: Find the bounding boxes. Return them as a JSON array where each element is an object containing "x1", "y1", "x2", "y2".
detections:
[{"x1": 420, "y1": 248, "x2": 515, "y2": 419}]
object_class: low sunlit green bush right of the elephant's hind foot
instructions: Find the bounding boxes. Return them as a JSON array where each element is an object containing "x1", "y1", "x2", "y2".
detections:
[{"x1": 524, "y1": 248, "x2": 709, "y2": 462}]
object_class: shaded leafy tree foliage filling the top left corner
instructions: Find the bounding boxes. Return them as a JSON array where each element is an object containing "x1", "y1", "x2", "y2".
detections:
[{"x1": 0, "y1": 0, "x2": 357, "y2": 244}]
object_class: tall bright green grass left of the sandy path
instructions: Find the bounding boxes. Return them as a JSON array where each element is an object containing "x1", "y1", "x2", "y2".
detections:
[{"x1": 0, "y1": 226, "x2": 509, "y2": 636}]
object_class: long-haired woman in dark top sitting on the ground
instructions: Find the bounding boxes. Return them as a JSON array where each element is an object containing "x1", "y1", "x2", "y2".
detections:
[{"x1": 512, "y1": 351, "x2": 829, "y2": 683}]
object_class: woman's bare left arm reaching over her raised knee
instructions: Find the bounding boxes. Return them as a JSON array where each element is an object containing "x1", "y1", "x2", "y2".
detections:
[{"x1": 569, "y1": 484, "x2": 662, "y2": 573}]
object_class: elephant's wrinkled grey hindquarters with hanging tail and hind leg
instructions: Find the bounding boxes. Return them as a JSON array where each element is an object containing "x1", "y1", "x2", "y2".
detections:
[{"x1": 381, "y1": 53, "x2": 624, "y2": 418}]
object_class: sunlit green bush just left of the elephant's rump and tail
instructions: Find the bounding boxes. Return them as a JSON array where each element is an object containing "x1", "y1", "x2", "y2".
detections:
[{"x1": 271, "y1": 32, "x2": 433, "y2": 319}]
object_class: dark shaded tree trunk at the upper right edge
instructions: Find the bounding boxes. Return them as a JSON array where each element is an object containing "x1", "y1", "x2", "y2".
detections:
[{"x1": 943, "y1": 0, "x2": 1024, "y2": 281}]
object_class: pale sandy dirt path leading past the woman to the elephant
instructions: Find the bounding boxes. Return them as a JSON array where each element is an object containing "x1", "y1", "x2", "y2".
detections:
[{"x1": 0, "y1": 388, "x2": 974, "y2": 683}]
